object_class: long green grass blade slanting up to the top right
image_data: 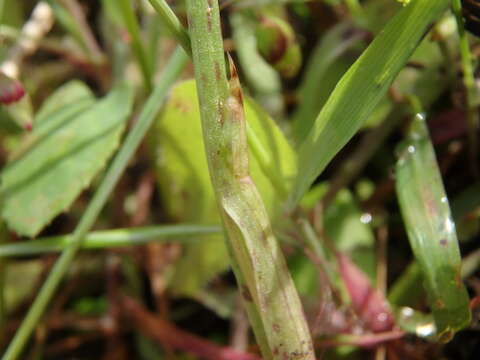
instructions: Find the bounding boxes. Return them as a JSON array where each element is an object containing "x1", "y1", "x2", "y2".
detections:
[{"x1": 288, "y1": 0, "x2": 450, "y2": 209}]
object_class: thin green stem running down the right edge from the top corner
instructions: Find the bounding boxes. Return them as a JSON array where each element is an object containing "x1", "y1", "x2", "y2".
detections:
[{"x1": 452, "y1": 0, "x2": 480, "y2": 177}]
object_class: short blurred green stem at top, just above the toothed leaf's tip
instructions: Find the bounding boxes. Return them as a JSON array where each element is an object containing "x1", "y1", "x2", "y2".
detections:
[{"x1": 118, "y1": 0, "x2": 153, "y2": 92}]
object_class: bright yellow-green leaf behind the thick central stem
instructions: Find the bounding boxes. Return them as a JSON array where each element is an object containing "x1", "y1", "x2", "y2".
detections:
[{"x1": 150, "y1": 80, "x2": 296, "y2": 296}]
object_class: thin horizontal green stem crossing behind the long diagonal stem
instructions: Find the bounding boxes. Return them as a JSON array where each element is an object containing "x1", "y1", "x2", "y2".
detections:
[{"x1": 0, "y1": 225, "x2": 221, "y2": 258}]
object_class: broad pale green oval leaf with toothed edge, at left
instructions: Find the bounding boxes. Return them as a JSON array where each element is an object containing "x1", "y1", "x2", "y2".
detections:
[{"x1": 0, "y1": 85, "x2": 133, "y2": 236}]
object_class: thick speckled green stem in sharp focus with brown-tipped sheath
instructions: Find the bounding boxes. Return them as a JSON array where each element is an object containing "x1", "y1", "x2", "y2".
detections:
[{"x1": 186, "y1": 0, "x2": 315, "y2": 360}]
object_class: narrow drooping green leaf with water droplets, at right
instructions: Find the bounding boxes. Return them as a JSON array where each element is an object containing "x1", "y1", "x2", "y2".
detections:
[{"x1": 396, "y1": 114, "x2": 470, "y2": 341}]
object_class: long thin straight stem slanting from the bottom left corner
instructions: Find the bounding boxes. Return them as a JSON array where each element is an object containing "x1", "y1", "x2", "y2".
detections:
[{"x1": 2, "y1": 49, "x2": 188, "y2": 360}]
